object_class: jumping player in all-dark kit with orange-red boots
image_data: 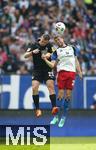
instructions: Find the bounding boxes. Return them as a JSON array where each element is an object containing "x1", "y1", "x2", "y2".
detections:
[{"x1": 24, "y1": 34, "x2": 58, "y2": 117}]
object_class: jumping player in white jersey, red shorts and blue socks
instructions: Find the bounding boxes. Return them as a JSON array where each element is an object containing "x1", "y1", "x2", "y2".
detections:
[{"x1": 42, "y1": 36, "x2": 82, "y2": 127}]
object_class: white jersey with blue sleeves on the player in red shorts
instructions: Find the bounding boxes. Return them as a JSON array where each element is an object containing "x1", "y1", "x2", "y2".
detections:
[{"x1": 52, "y1": 45, "x2": 76, "y2": 72}]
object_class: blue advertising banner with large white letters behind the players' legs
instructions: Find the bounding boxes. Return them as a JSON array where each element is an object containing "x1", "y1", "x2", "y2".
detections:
[{"x1": 0, "y1": 75, "x2": 96, "y2": 109}]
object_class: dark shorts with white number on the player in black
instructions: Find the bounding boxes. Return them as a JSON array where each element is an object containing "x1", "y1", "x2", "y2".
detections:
[{"x1": 32, "y1": 70, "x2": 55, "y2": 83}]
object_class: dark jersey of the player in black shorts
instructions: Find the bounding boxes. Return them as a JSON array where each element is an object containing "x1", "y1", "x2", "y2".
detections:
[{"x1": 28, "y1": 42, "x2": 52, "y2": 71}]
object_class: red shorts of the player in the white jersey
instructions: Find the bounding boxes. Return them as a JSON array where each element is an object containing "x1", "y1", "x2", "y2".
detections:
[{"x1": 57, "y1": 70, "x2": 76, "y2": 90}]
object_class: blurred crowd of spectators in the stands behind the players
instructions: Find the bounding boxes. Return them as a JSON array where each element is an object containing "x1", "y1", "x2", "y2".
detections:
[{"x1": 0, "y1": 0, "x2": 96, "y2": 75}]
